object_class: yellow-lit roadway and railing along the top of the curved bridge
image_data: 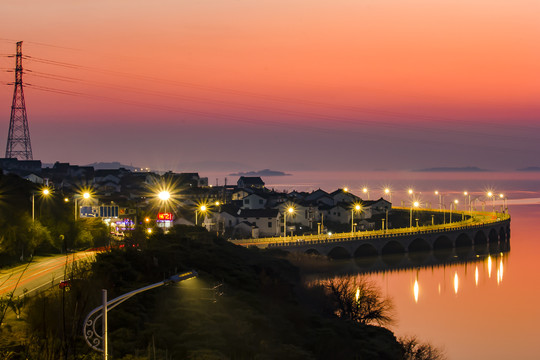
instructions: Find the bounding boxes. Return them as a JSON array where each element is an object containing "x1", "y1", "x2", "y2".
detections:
[{"x1": 230, "y1": 207, "x2": 510, "y2": 247}]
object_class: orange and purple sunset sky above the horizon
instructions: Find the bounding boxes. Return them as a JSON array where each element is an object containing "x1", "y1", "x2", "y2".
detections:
[{"x1": 0, "y1": 0, "x2": 540, "y2": 172}]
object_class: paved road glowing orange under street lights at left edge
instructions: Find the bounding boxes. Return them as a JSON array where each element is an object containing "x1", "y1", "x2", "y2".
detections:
[{"x1": 0, "y1": 251, "x2": 96, "y2": 296}]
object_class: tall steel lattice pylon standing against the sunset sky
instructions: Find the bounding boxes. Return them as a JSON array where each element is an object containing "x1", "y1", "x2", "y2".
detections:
[{"x1": 6, "y1": 41, "x2": 33, "y2": 160}]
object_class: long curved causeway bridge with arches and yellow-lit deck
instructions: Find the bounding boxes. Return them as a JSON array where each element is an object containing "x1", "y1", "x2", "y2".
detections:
[{"x1": 231, "y1": 209, "x2": 510, "y2": 259}]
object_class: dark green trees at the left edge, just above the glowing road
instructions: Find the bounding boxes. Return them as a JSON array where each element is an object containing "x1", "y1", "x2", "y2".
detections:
[{"x1": 0, "y1": 174, "x2": 110, "y2": 268}]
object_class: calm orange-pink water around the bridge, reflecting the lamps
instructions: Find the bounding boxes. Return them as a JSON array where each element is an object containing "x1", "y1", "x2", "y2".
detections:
[{"x1": 215, "y1": 172, "x2": 540, "y2": 360}]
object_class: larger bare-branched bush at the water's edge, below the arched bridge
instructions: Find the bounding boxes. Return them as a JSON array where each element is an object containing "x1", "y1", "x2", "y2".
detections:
[{"x1": 320, "y1": 276, "x2": 393, "y2": 326}]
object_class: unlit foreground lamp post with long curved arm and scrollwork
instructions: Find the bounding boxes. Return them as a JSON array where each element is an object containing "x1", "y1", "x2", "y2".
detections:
[{"x1": 83, "y1": 270, "x2": 198, "y2": 360}]
